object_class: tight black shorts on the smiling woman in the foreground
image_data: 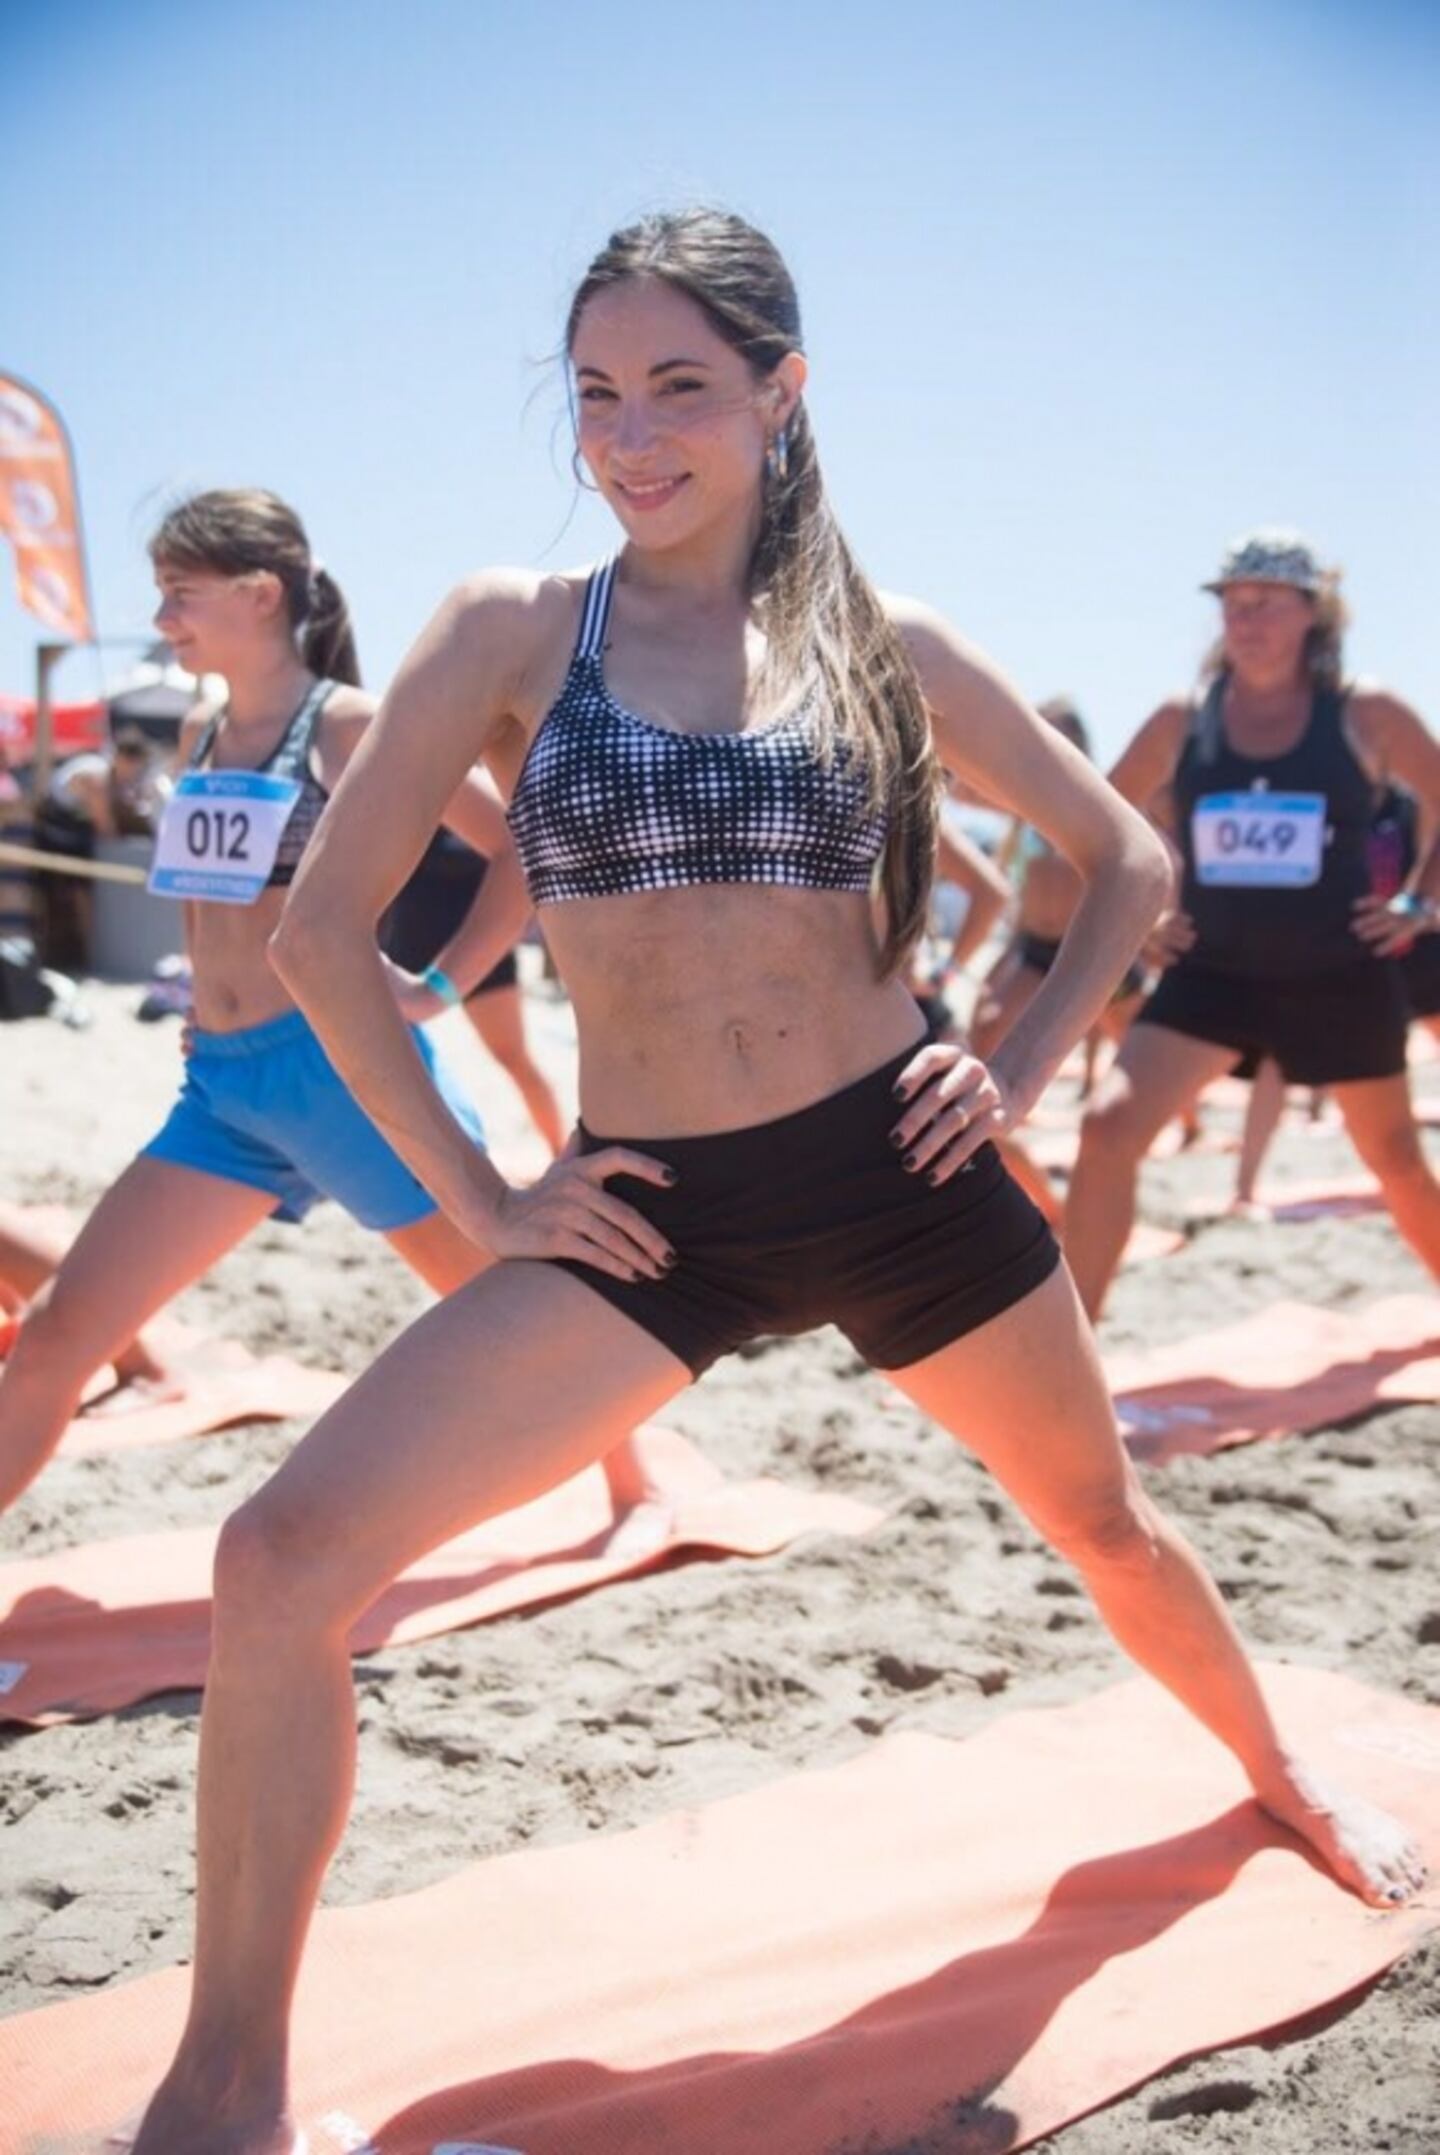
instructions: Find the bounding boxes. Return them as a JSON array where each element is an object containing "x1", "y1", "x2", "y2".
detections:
[{"x1": 554, "y1": 1041, "x2": 1061, "y2": 1377}]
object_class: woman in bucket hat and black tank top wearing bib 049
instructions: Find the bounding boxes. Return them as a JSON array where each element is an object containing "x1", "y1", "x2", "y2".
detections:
[{"x1": 1065, "y1": 530, "x2": 1440, "y2": 1315}]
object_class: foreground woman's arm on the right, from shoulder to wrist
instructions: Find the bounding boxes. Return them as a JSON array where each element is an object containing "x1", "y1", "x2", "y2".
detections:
[{"x1": 888, "y1": 599, "x2": 1173, "y2": 1129}]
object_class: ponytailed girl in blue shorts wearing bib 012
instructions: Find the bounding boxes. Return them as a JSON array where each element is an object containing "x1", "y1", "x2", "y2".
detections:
[{"x1": 0, "y1": 489, "x2": 647, "y2": 1532}]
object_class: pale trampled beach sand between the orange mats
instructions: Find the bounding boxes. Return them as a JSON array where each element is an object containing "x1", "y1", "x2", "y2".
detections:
[{"x1": 0, "y1": 987, "x2": 1440, "y2": 2155}]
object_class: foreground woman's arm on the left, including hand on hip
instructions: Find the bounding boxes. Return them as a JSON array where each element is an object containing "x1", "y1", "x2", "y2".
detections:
[{"x1": 269, "y1": 571, "x2": 668, "y2": 1278}]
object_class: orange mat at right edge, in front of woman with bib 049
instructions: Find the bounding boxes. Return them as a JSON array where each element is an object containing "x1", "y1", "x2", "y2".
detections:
[{"x1": 1106, "y1": 1295, "x2": 1440, "y2": 1463}]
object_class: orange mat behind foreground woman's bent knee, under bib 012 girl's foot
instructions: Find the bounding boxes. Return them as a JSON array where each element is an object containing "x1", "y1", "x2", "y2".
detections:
[{"x1": 0, "y1": 1424, "x2": 882, "y2": 1724}]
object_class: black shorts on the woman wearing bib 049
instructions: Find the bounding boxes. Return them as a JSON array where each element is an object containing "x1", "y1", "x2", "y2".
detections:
[{"x1": 1136, "y1": 957, "x2": 1410, "y2": 1084}]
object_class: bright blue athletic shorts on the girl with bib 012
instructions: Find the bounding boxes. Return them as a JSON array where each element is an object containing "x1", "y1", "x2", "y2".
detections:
[{"x1": 142, "y1": 1011, "x2": 485, "y2": 1231}]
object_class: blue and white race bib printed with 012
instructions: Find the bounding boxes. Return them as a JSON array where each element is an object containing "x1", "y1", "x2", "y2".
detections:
[{"x1": 149, "y1": 771, "x2": 300, "y2": 905}]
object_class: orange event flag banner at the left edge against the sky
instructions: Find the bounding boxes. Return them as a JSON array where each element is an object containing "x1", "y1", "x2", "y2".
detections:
[{"x1": 0, "y1": 373, "x2": 95, "y2": 644}]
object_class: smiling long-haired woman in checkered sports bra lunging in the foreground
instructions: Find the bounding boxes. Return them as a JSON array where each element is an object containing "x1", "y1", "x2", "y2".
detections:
[{"x1": 136, "y1": 211, "x2": 1418, "y2": 2155}]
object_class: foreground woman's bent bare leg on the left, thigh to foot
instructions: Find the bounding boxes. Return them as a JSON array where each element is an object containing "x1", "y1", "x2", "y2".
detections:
[{"x1": 136, "y1": 1263, "x2": 690, "y2": 2155}]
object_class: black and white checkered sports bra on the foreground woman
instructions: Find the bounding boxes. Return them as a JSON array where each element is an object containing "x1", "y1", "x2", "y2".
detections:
[{"x1": 509, "y1": 562, "x2": 886, "y2": 905}]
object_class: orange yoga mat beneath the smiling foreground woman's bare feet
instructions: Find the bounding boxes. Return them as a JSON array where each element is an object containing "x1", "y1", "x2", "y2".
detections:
[{"x1": 0, "y1": 1668, "x2": 1440, "y2": 2155}]
